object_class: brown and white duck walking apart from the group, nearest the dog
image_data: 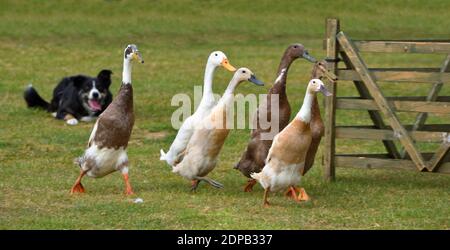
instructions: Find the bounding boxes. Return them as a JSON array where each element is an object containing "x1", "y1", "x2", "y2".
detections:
[{"x1": 70, "y1": 44, "x2": 144, "y2": 195}]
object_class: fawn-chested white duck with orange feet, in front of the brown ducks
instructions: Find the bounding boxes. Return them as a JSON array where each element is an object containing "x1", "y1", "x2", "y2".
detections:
[{"x1": 250, "y1": 79, "x2": 332, "y2": 206}]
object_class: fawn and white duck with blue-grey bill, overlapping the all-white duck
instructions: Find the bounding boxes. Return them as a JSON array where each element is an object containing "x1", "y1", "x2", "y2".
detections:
[{"x1": 172, "y1": 68, "x2": 264, "y2": 191}]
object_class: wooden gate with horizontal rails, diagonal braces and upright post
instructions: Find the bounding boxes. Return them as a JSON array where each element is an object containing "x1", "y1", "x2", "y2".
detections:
[{"x1": 323, "y1": 19, "x2": 450, "y2": 180}]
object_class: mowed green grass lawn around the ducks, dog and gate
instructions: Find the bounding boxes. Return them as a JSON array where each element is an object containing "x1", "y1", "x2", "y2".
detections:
[{"x1": 0, "y1": 0, "x2": 450, "y2": 229}]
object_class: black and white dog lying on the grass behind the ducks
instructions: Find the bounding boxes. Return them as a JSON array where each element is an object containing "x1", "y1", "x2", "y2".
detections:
[{"x1": 24, "y1": 69, "x2": 112, "y2": 125}]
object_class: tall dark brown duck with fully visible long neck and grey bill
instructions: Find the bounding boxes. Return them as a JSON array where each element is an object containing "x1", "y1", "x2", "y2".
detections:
[{"x1": 234, "y1": 43, "x2": 317, "y2": 192}]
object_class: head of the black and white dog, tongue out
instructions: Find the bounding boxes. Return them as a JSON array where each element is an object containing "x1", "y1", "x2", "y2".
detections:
[{"x1": 73, "y1": 69, "x2": 112, "y2": 114}]
